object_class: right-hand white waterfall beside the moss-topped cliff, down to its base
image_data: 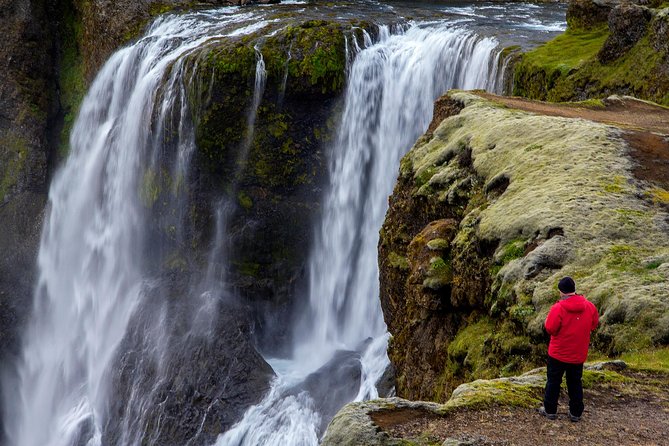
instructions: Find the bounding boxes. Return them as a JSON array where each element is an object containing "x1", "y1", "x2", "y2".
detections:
[{"x1": 216, "y1": 24, "x2": 501, "y2": 446}]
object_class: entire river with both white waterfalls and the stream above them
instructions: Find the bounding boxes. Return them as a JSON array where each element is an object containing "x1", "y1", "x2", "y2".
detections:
[{"x1": 3, "y1": 2, "x2": 565, "y2": 446}]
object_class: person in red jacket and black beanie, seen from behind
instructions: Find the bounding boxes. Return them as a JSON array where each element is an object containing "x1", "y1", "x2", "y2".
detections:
[{"x1": 539, "y1": 277, "x2": 599, "y2": 421}]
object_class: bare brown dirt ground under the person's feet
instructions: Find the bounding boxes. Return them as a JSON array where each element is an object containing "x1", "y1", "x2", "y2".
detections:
[{"x1": 372, "y1": 376, "x2": 669, "y2": 446}]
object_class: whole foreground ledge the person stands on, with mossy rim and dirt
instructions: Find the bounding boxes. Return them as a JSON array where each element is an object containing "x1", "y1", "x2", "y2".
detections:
[{"x1": 323, "y1": 356, "x2": 669, "y2": 446}]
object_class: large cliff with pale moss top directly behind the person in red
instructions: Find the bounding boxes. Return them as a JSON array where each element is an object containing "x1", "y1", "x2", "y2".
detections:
[{"x1": 379, "y1": 92, "x2": 669, "y2": 401}]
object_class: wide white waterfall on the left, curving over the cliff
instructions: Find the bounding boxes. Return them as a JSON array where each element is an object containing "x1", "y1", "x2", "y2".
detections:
[{"x1": 3, "y1": 8, "x2": 272, "y2": 446}]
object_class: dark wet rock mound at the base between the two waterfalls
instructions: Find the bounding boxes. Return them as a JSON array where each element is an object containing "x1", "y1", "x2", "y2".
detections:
[{"x1": 103, "y1": 296, "x2": 274, "y2": 446}]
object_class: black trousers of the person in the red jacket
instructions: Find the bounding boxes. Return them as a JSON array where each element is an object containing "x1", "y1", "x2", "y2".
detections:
[{"x1": 544, "y1": 356, "x2": 583, "y2": 417}]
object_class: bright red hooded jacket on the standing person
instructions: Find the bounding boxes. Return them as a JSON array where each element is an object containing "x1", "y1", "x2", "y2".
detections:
[{"x1": 544, "y1": 294, "x2": 599, "y2": 364}]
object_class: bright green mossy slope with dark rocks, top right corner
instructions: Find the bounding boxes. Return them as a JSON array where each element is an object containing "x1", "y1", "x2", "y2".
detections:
[{"x1": 513, "y1": 0, "x2": 669, "y2": 105}]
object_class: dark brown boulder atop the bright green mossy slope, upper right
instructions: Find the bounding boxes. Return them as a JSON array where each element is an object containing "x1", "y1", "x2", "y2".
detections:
[{"x1": 597, "y1": 3, "x2": 652, "y2": 64}]
